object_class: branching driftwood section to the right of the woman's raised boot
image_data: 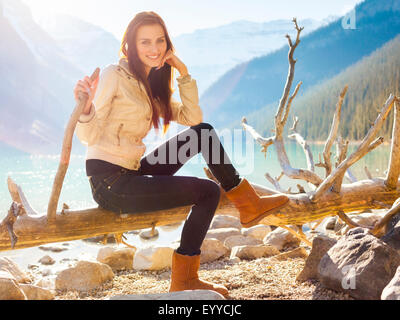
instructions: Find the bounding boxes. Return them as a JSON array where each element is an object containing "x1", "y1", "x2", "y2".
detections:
[{"x1": 242, "y1": 19, "x2": 400, "y2": 242}]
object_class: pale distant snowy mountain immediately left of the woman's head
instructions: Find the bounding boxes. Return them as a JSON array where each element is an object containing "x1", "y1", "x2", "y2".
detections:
[{"x1": 37, "y1": 14, "x2": 120, "y2": 74}]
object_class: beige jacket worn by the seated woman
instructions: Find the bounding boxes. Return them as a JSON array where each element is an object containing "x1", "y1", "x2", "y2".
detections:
[{"x1": 76, "y1": 59, "x2": 203, "y2": 170}]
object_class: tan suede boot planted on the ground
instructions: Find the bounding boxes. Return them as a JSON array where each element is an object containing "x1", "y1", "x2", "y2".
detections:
[{"x1": 169, "y1": 251, "x2": 228, "y2": 296}]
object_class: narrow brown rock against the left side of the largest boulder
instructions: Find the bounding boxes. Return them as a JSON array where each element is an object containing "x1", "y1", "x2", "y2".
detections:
[{"x1": 296, "y1": 235, "x2": 337, "y2": 281}]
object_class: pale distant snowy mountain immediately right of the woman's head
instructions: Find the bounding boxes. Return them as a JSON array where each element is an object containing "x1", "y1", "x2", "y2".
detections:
[{"x1": 172, "y1": 19, "x2": 326, "y2": 94}]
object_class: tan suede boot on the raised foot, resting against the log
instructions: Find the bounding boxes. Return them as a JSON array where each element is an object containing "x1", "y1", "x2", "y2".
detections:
[{"x1": 225, "y1": 179, "x2": 289, "y2": 228}]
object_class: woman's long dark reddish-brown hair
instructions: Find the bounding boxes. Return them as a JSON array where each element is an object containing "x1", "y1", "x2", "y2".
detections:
[{"x1": 120, "y1": 11, "x2": 175, "y2": 134}]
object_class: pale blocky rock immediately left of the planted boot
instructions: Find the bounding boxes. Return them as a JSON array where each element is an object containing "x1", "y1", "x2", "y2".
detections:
[{"x1": 133, "y1": 247, "x2": 174, "y2": 270}]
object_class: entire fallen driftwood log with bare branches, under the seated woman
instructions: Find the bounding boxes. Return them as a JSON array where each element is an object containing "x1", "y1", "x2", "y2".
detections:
[{"x1": 0, "y1": 19, "x2": 400, "y2": 251}]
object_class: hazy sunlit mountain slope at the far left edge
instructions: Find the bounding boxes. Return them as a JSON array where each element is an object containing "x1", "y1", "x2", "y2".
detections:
[{"x1": 0, "y1": 0, "x2": 80, "y2": 153}]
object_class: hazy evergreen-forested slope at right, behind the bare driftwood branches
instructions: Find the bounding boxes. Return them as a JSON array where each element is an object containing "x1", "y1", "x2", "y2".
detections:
[{"x1": 292, "y1": 35, "x2": 400, "y2": 140}]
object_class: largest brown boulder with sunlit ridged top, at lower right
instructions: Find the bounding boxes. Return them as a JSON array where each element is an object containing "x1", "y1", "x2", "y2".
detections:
[{"x1": 318, "y1": 228, "x2": 400, "y2": 300}]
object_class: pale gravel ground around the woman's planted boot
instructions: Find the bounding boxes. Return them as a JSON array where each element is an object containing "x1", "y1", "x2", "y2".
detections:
[{"x1": 55, "y1": 254, "x2": 352, "y2": 300}]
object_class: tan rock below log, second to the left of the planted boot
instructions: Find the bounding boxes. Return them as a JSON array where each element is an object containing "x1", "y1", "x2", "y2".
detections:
[{"x1": 97, "y1": 247, "x2": 136, "y2": 271}]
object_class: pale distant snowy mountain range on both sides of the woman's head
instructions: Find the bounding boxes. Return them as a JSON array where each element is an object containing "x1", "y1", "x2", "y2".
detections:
[{"x1": 37, "y1": 15, "x2": 324, "y2": 94}]
